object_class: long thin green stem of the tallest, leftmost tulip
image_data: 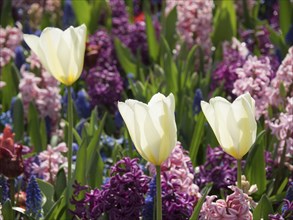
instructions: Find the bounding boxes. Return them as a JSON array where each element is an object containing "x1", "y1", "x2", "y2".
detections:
[{"x1": 67, "y1": 86, "x2": 73, "y2": 201}]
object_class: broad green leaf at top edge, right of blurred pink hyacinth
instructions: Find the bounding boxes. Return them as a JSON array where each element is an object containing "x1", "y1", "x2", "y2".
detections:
[{"x1": 212, "y1": 0, "x2": 237, "y2": 46}]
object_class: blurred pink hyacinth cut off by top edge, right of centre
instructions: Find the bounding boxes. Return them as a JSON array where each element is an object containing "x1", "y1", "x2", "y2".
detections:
[{"x1": 166, "y1": 0, "x2": 214, "y2": 67}]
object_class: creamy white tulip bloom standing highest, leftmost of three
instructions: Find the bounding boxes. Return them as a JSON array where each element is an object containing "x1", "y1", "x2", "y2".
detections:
[{"x1": 24, "y1": 24, "x2": 86, "y2": 86}]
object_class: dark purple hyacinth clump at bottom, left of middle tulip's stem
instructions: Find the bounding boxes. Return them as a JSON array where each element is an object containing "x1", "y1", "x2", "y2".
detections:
[{"x1": 71, "y1": 157, "x2": 150, "y2": 220}]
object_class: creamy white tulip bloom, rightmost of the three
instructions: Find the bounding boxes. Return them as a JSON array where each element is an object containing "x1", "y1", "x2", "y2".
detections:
[{"x1": 201, "y1": 93, "x2": 257, "y2": 160}]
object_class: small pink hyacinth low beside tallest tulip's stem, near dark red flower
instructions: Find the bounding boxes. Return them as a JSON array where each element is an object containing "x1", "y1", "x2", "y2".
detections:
[{"x1": 32, "y1": 143, "x2": 67, "y2": 183}]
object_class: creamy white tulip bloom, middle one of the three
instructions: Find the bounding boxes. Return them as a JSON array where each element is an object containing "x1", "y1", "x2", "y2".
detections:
[{"x1": 118, "y1": 93, "x2": 177, "y2": 166}]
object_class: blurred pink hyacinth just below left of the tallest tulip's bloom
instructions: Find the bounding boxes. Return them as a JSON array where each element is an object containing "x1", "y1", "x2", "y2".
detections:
[{"x1": 19, "y1": 54, "x2": 61, "y2": 127}]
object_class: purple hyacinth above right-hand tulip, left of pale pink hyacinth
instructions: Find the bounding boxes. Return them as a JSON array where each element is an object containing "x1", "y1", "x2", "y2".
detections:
[{"x1": 212, "y1": 38, "x2": 249, "y2": 98}]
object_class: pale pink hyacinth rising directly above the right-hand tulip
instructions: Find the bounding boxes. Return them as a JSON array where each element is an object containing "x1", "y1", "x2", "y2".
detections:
[{"x1": 232, "y1": 56, "x2": 273, "y2": 119}]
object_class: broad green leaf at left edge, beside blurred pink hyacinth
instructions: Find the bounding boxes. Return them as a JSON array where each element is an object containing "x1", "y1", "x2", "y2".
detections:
[{"x1": 1, "y1": 62, "x2": 19, "y2": 112}]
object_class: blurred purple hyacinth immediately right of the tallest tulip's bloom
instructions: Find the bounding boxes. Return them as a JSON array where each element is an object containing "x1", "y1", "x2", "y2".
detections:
[{"x1": 84, "y1": 30, "x2": 123, "y2": 111}]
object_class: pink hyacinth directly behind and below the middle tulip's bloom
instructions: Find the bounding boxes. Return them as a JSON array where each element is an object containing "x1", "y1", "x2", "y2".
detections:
[{"x1": 149, "y1": 142, "x2": 201, "y2": 200}]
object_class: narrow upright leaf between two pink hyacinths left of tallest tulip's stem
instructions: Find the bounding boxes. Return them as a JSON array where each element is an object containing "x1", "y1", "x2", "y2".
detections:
[{"x1": 28, "y1": 103, "x2": 43, "y2": 152}]
